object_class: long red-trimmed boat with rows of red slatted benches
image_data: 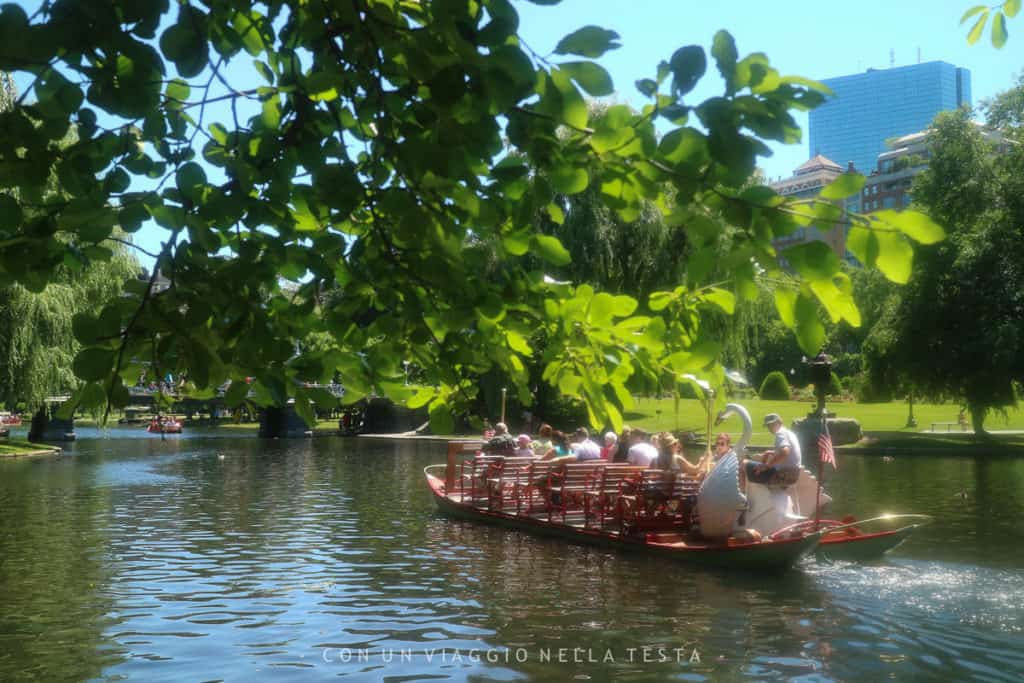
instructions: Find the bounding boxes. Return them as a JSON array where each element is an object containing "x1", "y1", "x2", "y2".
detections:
[{"x1": 424, "y1": 441, "x2": 822, "y2": 571}]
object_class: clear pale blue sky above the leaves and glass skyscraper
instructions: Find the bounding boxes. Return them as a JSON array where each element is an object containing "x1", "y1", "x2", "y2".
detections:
[{"x1": 515, "y1": 0, "x2": 1024, "y2": 178}]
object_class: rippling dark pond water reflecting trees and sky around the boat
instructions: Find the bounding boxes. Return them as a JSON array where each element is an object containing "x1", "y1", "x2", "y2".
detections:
[{"x1": 0, "y1": 429, "x2": 1024, "y2": 681}]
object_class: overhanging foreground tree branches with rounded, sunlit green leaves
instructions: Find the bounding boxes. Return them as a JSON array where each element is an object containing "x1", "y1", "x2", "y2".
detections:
[{"x1": 0, "y1": 0, "x2": 942, "y2": 431}]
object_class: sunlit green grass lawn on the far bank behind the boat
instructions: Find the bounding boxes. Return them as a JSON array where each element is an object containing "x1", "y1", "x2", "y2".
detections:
[{"x1": 626, "y1": 398, "x2": 1024, "y2": 440}]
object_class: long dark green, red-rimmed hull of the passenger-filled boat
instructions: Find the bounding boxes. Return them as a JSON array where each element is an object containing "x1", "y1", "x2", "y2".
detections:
[{"x1": 426, "y1": 473, "x2": 820, "y2": 571}]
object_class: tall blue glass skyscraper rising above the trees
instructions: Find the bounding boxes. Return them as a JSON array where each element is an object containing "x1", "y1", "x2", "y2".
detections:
[{"x1": 810, "y1": 61, "x2": 971, "y2": 174}]
